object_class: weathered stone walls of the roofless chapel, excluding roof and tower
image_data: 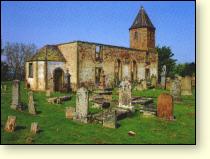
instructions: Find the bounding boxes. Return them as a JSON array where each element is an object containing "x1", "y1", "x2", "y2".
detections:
[{"x1": 26, "y1": 41, "x2": 158, "y2": 90}]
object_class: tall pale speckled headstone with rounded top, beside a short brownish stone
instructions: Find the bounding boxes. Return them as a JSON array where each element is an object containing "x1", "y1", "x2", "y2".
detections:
[{"x1": 74, "y1": 87, "x2": 89, "y2": 123}]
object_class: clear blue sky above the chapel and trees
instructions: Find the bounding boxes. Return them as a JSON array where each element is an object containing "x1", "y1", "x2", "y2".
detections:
[{"x1": 1, "y1": 1, "x2": 195, "y2": 63}]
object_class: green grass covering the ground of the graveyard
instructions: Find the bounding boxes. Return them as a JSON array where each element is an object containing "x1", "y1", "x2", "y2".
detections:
[{"x1": 1, "y1": 82, "x2": 195, "y2": 144}]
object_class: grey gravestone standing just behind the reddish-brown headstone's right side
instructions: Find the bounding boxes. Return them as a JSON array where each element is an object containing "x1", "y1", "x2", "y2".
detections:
[{"x1": 170, "y1": 77, "x2": 181, "y2": 101}]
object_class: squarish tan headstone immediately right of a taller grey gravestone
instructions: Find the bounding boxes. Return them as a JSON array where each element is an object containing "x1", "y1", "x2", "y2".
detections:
[{"x1": 181, "y1": 76, "x2": 192, "y2": 96}]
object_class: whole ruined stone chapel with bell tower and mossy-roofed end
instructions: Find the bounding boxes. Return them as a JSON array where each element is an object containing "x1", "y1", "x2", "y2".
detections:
[{"x1": 25, "y1": 7, "x2": 158, "y2": 91}]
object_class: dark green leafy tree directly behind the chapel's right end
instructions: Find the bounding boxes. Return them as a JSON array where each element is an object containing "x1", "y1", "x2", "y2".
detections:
[{"x1": 156, "y1": 46, "x2": 176, "y2": 80}]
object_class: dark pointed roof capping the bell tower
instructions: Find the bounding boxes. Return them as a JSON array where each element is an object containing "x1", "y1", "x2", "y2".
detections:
[{"x1": 129, "y1": 7, "x2": 155, "y2": 30}]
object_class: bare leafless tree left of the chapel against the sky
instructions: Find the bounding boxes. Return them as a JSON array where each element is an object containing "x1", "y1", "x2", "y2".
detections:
[{"x1": 4, "y1": 43, "x2": 36, "y2": 80}]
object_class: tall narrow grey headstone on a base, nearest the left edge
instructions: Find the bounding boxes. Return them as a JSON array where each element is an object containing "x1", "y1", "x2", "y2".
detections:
[{"x1": 11, "y1": 80, "x2": 22, "y2": 110}]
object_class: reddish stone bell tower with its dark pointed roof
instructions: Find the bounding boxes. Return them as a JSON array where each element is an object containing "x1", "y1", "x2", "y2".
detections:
[{"x1": 129, "y1": 7, "x2": 155, "y2": 50}]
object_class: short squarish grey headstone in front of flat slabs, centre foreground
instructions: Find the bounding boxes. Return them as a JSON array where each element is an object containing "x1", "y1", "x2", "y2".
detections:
[{"x1": 103, "y1": 111, "x2": 117, "y2": 129}]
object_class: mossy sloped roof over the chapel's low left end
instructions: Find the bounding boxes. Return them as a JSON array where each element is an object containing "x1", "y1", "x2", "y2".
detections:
[{"x1": 28, "y1": 45, "x2": 66, "y2": 62}]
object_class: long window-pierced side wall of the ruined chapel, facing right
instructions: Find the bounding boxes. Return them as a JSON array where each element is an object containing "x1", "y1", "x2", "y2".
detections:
[{"x1": 78, "y1": 42, "x2": 158, "y2": 87}]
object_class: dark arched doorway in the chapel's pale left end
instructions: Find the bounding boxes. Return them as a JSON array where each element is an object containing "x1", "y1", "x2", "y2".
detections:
[{"x1": 53, "y1": 68, "x2": 64, "y2": 91}]
